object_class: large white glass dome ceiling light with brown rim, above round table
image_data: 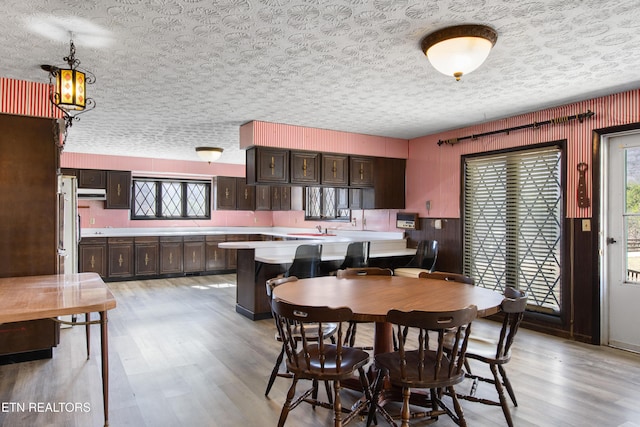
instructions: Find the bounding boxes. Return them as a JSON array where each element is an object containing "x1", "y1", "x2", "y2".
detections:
[{"x1": 422, "y1": 25, "x2": 498, "y2": 80}]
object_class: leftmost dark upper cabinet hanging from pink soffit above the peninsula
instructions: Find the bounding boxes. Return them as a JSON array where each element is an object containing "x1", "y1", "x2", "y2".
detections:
[{"x1": 246, "y1": 147, "x2": 289, "y2": 185}]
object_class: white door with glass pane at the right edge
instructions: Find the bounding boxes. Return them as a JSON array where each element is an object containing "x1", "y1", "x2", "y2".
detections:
[{"x1": 602, "y1": 133, "x2": 640, "y2": 352}]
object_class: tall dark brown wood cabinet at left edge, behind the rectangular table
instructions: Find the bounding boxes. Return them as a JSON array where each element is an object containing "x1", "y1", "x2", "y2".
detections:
[{"x1": 0, "y1": 114, "x2": 59, "y2": 360}]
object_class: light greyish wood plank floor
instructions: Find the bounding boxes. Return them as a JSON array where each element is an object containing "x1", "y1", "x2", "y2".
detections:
[{"x1": 0, "y1": 275, "x2": 640, "y2": 427}]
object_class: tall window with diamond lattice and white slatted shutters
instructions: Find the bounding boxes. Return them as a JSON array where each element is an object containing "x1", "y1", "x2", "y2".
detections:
[{"x1": 463, "y1": 146, "x2": 563, "y2": 314}]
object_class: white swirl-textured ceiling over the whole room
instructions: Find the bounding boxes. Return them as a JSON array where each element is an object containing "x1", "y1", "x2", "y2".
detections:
[{"x1": 0, "y1": 0, "x2": 640, "y2": 163}]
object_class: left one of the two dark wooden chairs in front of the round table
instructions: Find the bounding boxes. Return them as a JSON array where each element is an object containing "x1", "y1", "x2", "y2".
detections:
[{"x1": 272, "y1": 299, "x2": 371, "y2": 427}]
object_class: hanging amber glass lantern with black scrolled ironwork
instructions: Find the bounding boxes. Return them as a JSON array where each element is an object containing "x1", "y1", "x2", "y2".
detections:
[{"x1": 40, "y1": 33, "x2": 96, "y2": 146}]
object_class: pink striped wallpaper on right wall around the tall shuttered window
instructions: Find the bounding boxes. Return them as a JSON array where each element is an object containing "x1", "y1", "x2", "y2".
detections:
[{"x1": 406, "y1": 90, "x2": 640, "y2": 218}]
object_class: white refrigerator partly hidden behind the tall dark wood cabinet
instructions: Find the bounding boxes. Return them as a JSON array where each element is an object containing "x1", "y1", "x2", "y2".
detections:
[{"x1": 58, "y1": 175, "x2": 80, "y2": 274}]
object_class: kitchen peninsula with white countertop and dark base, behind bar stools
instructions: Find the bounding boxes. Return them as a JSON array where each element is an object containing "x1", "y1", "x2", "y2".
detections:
[{"x1": 219, "y1": 230, "x2": 415, "y2": 320}]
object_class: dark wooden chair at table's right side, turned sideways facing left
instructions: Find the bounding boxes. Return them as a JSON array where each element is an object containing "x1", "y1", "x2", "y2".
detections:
[{"x1": 458, "y1": 286, "x2": 527, "y2": 427}]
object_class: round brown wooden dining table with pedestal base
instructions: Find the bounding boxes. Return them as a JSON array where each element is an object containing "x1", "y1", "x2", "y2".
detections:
[{"x1": 273, "y1": 275, "x2": 503, "y2": 354}]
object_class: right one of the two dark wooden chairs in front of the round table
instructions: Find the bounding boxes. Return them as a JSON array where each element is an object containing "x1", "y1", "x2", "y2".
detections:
[{"x1": 367, "y1": 305, "x2": 477, "y2": 426}]
